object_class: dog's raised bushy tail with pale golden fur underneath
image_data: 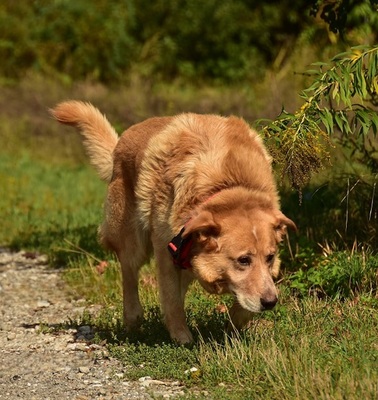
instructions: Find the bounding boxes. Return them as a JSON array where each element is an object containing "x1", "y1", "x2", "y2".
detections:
[{"x1": 50, "y1": 101, "x2": 118, "y2": 182}]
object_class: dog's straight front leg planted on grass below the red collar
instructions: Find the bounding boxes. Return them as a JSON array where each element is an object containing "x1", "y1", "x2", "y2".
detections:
[{"x1": 155, "y1": 248, "x2": 193, "y2": 344}]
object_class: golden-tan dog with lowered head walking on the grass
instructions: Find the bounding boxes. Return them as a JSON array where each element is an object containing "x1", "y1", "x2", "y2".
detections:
[{"x1": 50, "y1": 101, "x2": 296, "y2": 344}]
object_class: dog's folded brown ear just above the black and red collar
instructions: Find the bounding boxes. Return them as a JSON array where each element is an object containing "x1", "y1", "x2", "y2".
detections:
[{"x1": 182, "y1": 211, "x2": 220, "y2": 247}]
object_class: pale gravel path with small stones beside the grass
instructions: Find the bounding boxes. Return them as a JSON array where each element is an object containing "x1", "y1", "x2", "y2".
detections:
[{"x1": 0, "y1": 248, "x2": 188, "y2": 400}]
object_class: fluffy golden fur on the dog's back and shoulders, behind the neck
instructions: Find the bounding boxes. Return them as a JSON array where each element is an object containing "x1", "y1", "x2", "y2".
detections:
[{"x1": 136, "y1": 114, "x2": 279, "y2": 230}]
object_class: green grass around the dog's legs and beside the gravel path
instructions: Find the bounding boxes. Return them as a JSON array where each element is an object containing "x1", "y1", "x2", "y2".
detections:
[{"x1": 0, "y1": 78, "x2": 378, "y2": 400}]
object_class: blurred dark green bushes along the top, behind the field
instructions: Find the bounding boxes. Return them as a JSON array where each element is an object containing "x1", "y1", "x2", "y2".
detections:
[{"x1": 0, "y1": 0, "x2": 378, "y2": 84}]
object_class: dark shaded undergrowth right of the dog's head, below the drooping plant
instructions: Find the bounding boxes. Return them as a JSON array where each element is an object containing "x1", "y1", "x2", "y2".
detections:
[{"x1": 281, "y1": 176, "x2": 378, "y2": 248}]
